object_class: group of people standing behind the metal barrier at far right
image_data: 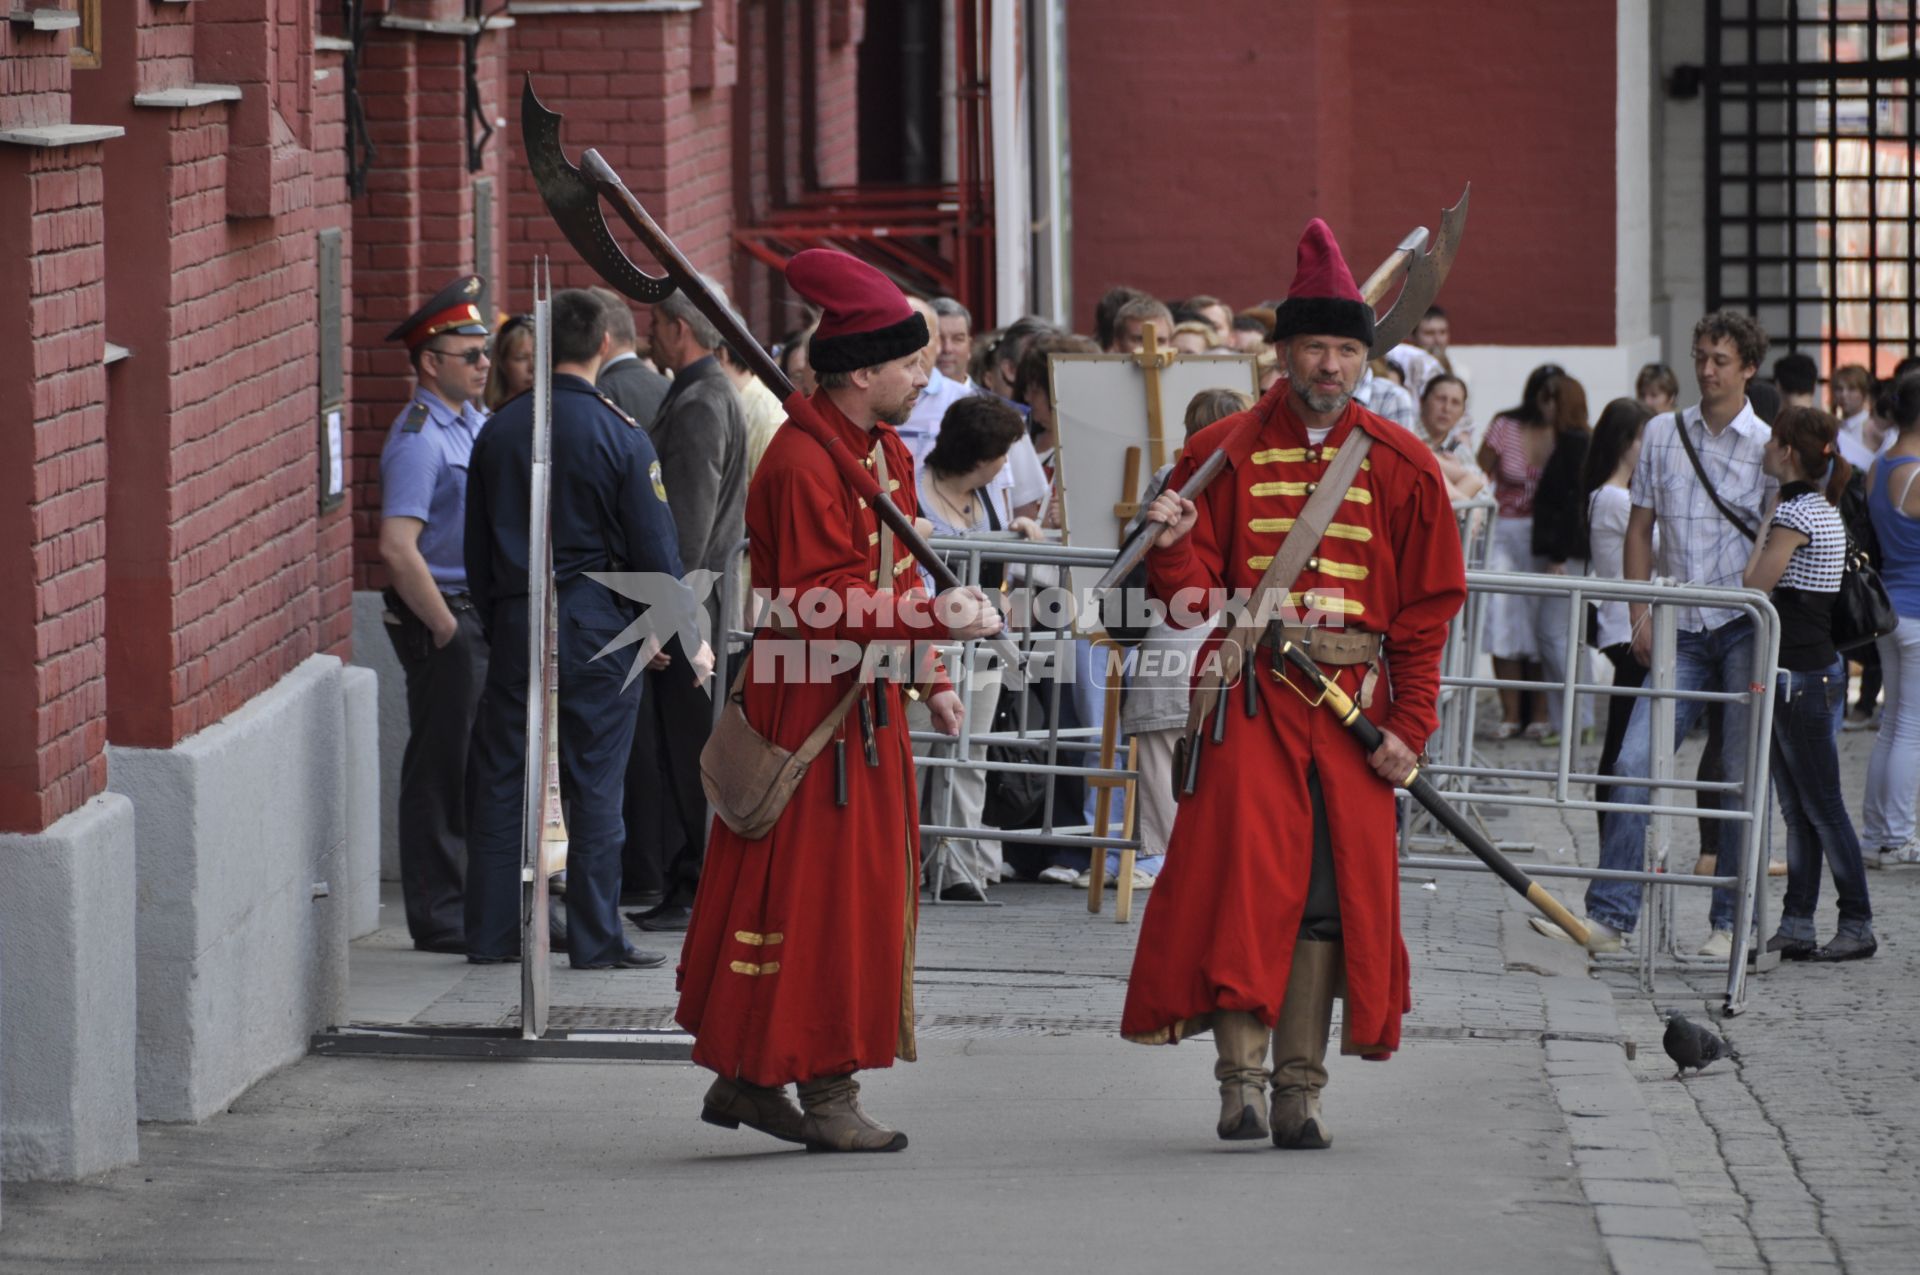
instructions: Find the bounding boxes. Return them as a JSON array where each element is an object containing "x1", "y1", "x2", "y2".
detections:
[{"x1": 1474, "y1": 311, "x2": 1920, "y2": 962}]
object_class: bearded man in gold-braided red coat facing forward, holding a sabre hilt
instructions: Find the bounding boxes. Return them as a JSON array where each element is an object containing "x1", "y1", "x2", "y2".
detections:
[{"x1": 1121, "y1": 219, "x2": 1467, "y2": 1148}]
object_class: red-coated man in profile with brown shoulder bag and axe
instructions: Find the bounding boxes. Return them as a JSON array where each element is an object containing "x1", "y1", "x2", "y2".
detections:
[{"x1": 678, "y1": 250, "x2": 1000, "y2": 1150}]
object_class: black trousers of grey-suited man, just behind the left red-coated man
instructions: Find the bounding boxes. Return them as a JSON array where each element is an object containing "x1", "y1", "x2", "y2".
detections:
[{"x1": 622, "y1": 641, "x2": 714, "y2": 906}]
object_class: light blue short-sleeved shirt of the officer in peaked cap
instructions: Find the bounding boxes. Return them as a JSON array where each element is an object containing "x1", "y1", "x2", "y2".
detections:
[{"x1": 380, "y1": 388, "x2": 486, "y2": 593}]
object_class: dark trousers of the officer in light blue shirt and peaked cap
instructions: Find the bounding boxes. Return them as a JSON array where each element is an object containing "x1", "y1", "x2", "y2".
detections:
[{"x1": 386, "y1": 589, "x2": 488, "y2": 945}]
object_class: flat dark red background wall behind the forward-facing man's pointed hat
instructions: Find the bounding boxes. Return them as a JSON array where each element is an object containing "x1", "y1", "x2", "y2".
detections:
[{"x1": 1068, "y1": 0, "x2": 1615, "y2": 344}]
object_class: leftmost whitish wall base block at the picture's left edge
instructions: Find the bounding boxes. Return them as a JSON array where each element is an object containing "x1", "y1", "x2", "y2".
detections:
[{"x1": 0, "y1": 793, "x2": 140, "y2": 1179}]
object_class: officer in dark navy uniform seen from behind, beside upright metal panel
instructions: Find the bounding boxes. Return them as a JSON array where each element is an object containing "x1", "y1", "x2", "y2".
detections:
[{"x1": 467, "y1": 290, "x2": 712, "y2": 970}]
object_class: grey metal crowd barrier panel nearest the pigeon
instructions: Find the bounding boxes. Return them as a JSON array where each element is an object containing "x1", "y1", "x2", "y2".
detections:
[{"x1": 1402, "y1": 570, "x2": 1780, "y2": 1014}]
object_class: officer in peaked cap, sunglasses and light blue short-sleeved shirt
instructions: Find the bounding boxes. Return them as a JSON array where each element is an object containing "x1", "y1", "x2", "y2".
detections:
[{"x1": 380, "y1": 275, "x2": 488, "y2": 952}]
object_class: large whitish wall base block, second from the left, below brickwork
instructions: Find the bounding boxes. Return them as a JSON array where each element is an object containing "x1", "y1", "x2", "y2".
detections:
[{"x1": 108, "y1": 655, "x2": 359, "y2": 1121}]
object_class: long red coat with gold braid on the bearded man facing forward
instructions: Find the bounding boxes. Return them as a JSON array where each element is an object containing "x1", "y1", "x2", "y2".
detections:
[{"x1": 1121, "y1": 380, "x2": 1467, "y2": 1058}]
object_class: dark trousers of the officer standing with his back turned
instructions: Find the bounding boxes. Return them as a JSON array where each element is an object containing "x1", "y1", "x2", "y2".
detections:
[{"x1": 467, "y1": 576, "x2": 641, "y2": 966}]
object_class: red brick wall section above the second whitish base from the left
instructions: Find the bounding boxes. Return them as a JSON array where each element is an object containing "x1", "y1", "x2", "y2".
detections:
[{"x1": 75, "y1": 0, "x2": 351, "y2": 747}]
